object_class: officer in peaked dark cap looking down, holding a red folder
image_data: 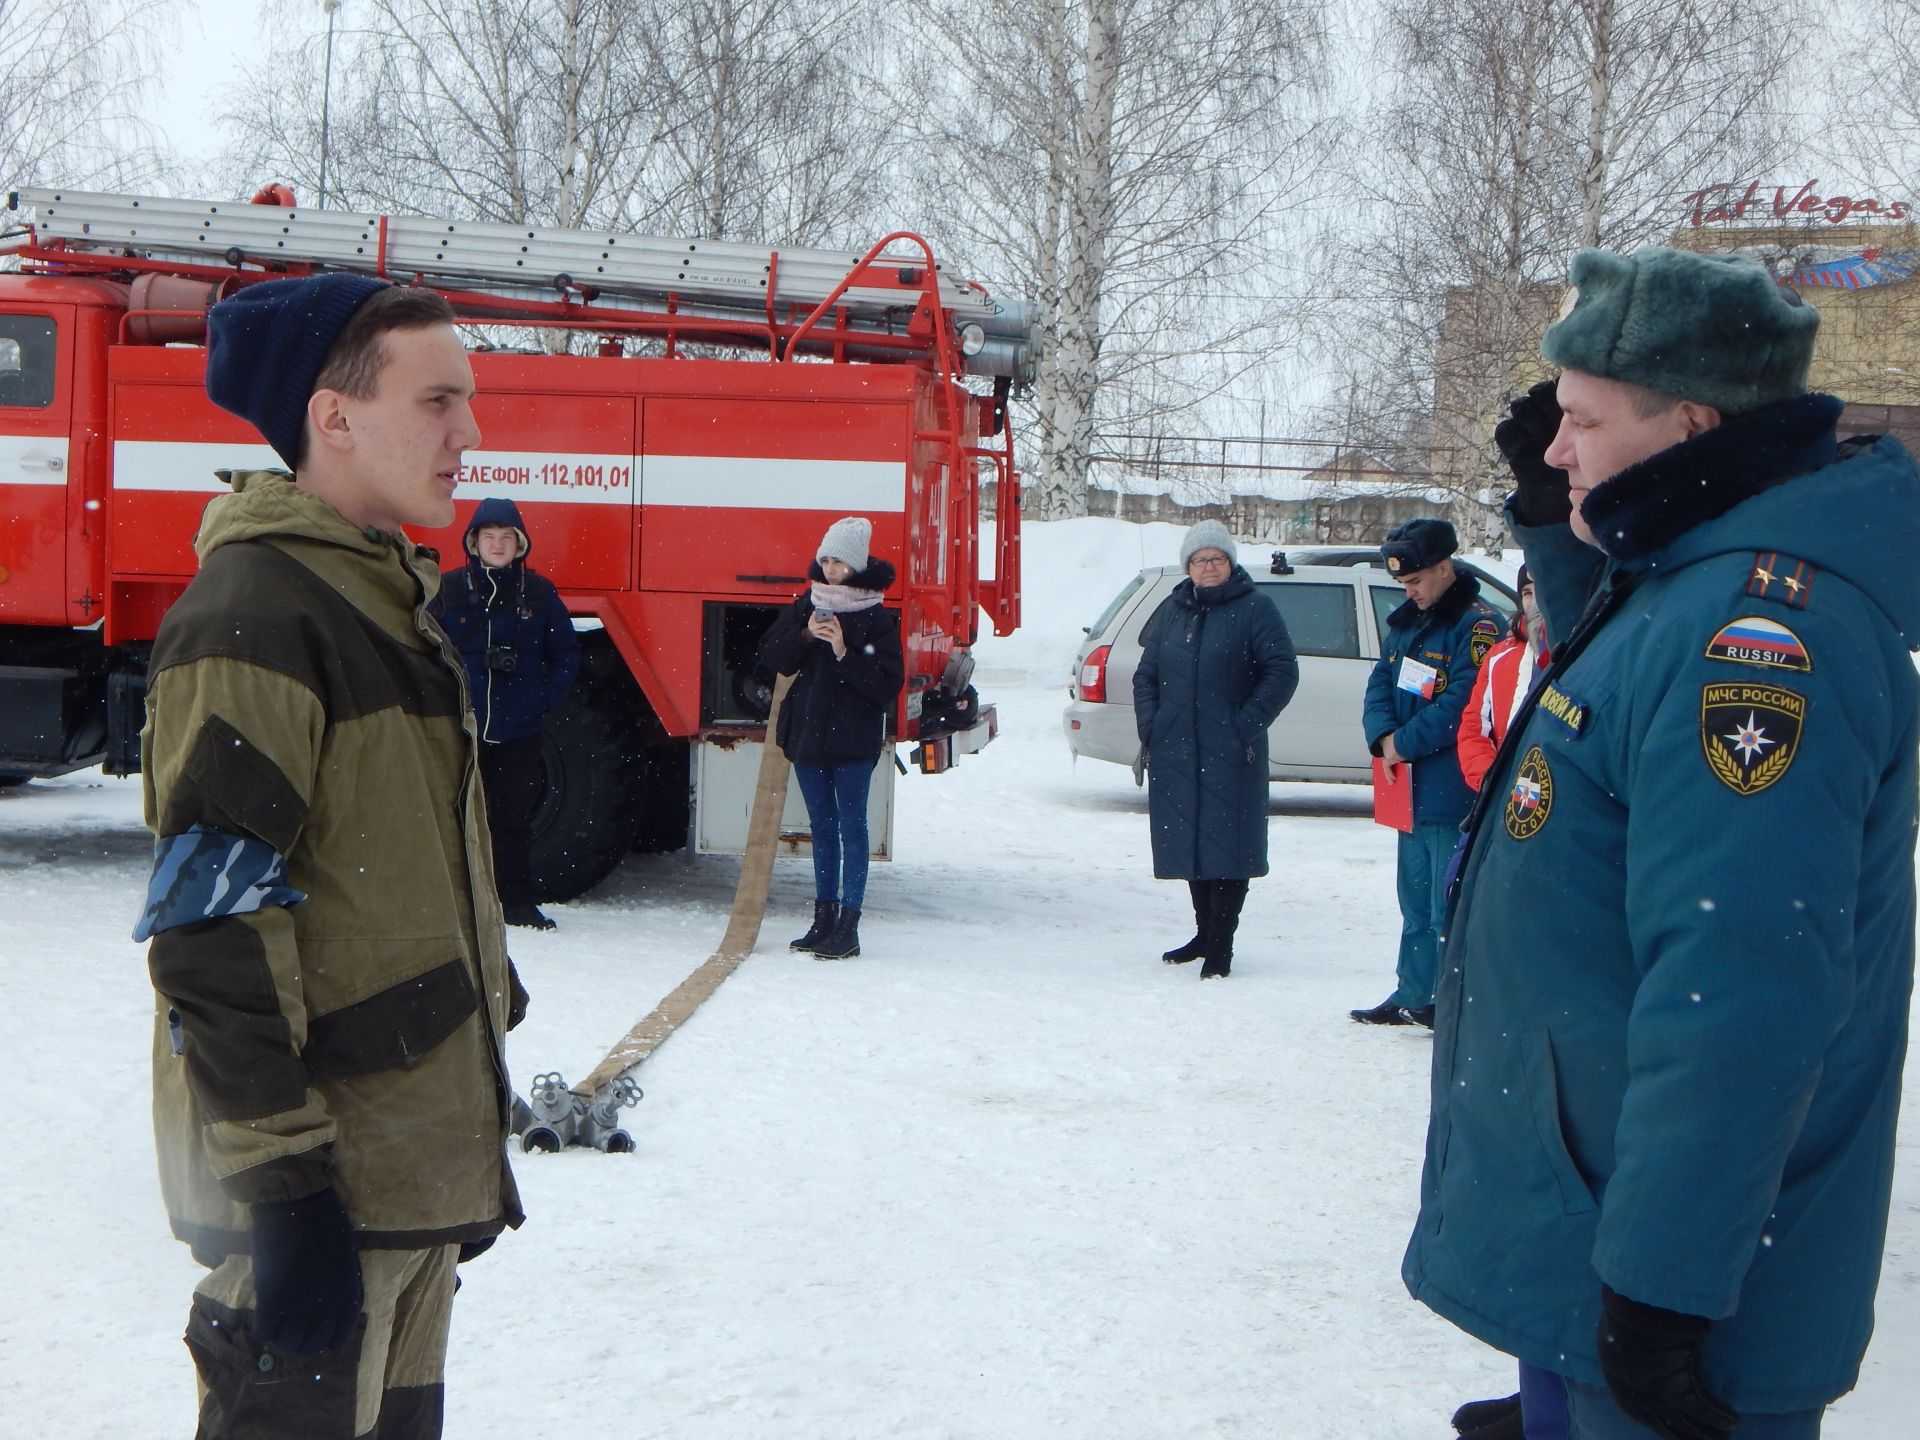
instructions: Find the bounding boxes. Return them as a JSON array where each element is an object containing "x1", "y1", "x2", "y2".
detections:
[{"x1": 1352, "y1": 518, "x2": 1505, "y2": 1029}]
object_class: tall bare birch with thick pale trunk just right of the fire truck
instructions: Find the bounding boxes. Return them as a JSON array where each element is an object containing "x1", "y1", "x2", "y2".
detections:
[{"x1": 891, "y1": 0, "x2": 1323, "y2": 516}]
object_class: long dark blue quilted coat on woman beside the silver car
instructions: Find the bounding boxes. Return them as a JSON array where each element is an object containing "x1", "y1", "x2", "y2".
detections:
[{"x1": 1133, "y1": 564, "x2": 1300, "y2": 879}]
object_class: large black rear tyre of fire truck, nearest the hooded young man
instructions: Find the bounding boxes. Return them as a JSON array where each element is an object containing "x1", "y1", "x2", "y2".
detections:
[{"x1": 534, "y1": 672, "x2": 645, "y2": 900}]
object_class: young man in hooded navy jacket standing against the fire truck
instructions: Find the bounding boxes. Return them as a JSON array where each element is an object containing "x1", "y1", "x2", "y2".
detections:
[{"x1": 440, "y1": 497, "x2": 580, "y2": 929}]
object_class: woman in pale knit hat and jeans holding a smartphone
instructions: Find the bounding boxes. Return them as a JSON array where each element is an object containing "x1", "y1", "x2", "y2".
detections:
[{"x1": 756, "y1": 515, "x2": 906, "y2": 960}]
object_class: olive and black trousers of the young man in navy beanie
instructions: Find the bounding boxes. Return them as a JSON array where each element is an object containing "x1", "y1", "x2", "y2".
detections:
[{"x1": 186, "y1": 1244, "x2": 459, "y2": 1440}]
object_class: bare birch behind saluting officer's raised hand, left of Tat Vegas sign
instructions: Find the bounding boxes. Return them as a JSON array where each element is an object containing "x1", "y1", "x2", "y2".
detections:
[{"x1": 1342, "y1": 0, "x2": 1789, "y2": 528}]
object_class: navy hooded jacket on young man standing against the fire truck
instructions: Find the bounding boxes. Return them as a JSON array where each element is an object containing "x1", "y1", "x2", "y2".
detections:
[{"x1": 436, "y1": 497, "x2": 580, "y2": 741}]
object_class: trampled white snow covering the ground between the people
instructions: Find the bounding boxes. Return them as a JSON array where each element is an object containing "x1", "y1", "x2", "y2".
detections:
[{"x1": 0, "y1": 520, "x2": 1920, "y2": 1440}]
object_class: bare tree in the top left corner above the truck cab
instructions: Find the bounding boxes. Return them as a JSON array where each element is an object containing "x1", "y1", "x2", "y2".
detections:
[{"x1": 0, "y1": 0, "x2": 163, "y2": 192}]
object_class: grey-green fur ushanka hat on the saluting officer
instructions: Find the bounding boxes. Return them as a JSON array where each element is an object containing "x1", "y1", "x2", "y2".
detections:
[{"x1": 1540, "y1": 248, "x2": 1820, "y2": 415}]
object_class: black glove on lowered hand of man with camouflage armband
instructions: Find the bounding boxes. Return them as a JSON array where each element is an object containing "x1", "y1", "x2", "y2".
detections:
[{"x1": 248, "y1": 1188, "x2": 363, "y2": 1356}]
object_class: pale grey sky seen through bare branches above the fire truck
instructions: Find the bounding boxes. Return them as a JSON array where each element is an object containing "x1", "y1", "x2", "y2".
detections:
[{"x1": 0, "y1": 0, "x2": 1920, "y2": 515}]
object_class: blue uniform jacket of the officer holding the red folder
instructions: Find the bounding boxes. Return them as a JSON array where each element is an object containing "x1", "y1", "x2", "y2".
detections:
[{"x1": 1365, "y1": 572, "x2": 1507, "y2": 826}]
